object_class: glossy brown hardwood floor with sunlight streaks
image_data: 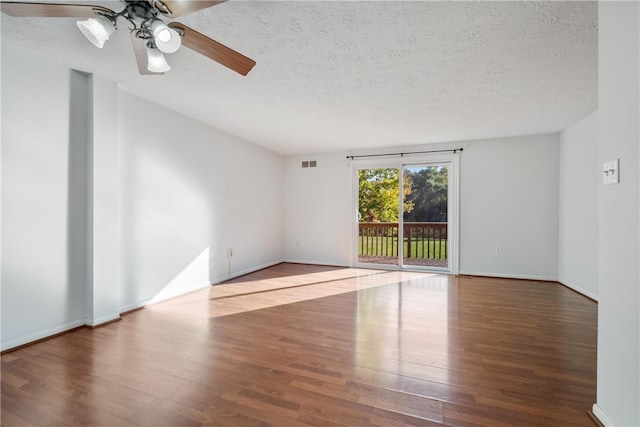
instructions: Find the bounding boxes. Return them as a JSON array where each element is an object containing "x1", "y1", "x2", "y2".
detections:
[{"x1": 1, "y1": 264, "x2": 597, "y2": 427}]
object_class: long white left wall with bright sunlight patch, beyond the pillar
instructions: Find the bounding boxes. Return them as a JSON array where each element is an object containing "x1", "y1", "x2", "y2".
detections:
[{"x1": 119, "y1": 92, "x2": 283, "y2": 310}]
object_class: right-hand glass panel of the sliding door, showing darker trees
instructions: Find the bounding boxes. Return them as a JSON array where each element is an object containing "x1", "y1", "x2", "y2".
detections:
[{"x1": 400, "y1": 164, "x2": 449, "y2": 269}]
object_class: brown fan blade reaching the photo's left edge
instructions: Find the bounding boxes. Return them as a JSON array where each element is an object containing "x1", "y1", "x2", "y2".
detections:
[{"x1": 0, "y1": 1, "x2": 115, "y2": 18}]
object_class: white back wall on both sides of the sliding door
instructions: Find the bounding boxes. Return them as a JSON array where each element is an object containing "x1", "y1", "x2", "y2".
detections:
[{"x1": 284, "y1": 135, "x2": 558, "y2": 280}]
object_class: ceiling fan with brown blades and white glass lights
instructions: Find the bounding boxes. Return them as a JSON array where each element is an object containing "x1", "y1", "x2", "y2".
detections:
[{"x1": 0, "y1": 0, "x2": 256, "y2": 76}]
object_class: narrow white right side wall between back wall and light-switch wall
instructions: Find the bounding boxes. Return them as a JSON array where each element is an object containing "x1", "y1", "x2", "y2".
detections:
[{"x1": 558, "y1": 112, "x2": 600, "y2": 299}]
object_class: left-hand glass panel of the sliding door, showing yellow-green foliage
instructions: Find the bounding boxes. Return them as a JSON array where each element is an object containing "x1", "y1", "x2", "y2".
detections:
[{"x1": 357, "y1": 168, "x2": 400, "y2": 266}]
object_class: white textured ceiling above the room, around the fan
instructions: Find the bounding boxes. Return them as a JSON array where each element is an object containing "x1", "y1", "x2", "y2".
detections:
[{"x1": 2, "y1": 0, "x2": 598, "y2": 154}]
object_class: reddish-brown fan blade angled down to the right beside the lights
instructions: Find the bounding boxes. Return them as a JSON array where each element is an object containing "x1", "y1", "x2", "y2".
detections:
[{"x1": 169, "y1": 22, "x2": 256, "y2": 76}]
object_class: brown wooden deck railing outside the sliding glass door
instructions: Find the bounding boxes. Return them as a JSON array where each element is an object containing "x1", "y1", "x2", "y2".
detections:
[{"x1": 358, "y1": 222, "x2": 447, "y2": 260}]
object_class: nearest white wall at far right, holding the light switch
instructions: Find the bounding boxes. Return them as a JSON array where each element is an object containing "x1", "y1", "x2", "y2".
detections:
[{"x1": 594, "y1": 1, "x2": 640, "y2": 426}]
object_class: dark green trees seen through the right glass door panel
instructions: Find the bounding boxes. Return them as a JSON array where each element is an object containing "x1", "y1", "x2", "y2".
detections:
[{"x1": 403, "y1": 166, "x2": 449, "y2": 222}]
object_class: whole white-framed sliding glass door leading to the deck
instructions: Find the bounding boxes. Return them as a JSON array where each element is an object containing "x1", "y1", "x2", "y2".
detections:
[{"x1": 354, "y1": 155, "x2": 457, "y2": 271}]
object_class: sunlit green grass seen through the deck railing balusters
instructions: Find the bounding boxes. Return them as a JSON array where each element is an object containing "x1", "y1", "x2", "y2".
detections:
[{"x1": 358, "y1": 236, "x2": 447, "y2": 259}]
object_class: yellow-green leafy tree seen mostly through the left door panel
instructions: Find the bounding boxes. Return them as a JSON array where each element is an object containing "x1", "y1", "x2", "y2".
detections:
[{"x1": 358, "y1": 168, "x2": 413, "y2": 222}]
